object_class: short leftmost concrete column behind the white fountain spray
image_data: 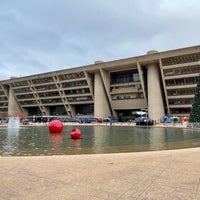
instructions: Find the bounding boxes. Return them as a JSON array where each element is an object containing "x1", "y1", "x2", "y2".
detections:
[{"x1": 8, "y1": 89, "x2": 22, "y2": 116}]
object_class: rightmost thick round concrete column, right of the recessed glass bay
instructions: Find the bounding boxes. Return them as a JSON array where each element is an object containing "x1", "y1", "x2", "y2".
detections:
[{"x1": 147, "y1": 64, "x2": 164, "y2": 122}]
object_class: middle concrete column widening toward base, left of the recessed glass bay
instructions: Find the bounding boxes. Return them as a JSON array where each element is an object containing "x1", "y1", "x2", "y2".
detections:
[{"x1": 94, "y1": 72, "x2": 111, "y2": 118}]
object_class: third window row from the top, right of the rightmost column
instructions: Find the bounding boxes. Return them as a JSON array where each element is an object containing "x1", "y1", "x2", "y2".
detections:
[{"x1": 165, "y1": 77, "x2": 198, "y2": 86}]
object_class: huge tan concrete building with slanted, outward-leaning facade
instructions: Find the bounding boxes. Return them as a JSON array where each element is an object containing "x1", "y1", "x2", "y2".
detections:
[{"x1": 0, "y1": 46, "x2": 200, "y2": 121}]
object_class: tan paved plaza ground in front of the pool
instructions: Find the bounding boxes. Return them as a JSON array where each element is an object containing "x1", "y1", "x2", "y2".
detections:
[{"x1": 0, "y1": 148, "x2": 200, "y2": 200}]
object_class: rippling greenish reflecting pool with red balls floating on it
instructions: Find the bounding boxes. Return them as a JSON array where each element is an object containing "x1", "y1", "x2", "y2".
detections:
[{"x1": 0, "y1": 126, "x2": 200, "y2": 156}]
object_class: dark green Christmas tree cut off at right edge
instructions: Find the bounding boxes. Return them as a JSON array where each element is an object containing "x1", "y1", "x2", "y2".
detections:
[{"x1": 189, "y1": 77, "x2": 200, "y2": 124}]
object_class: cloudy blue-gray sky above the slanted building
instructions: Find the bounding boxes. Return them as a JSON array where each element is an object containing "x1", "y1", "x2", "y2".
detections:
[{"x1": 0, "y1": 0, "x2": 200, "y2": 80}]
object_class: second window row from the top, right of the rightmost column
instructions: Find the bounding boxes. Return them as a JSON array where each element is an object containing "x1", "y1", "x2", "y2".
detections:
[{"x1": 163, "y1": 65, "x2": 200, "y2": 76}]
